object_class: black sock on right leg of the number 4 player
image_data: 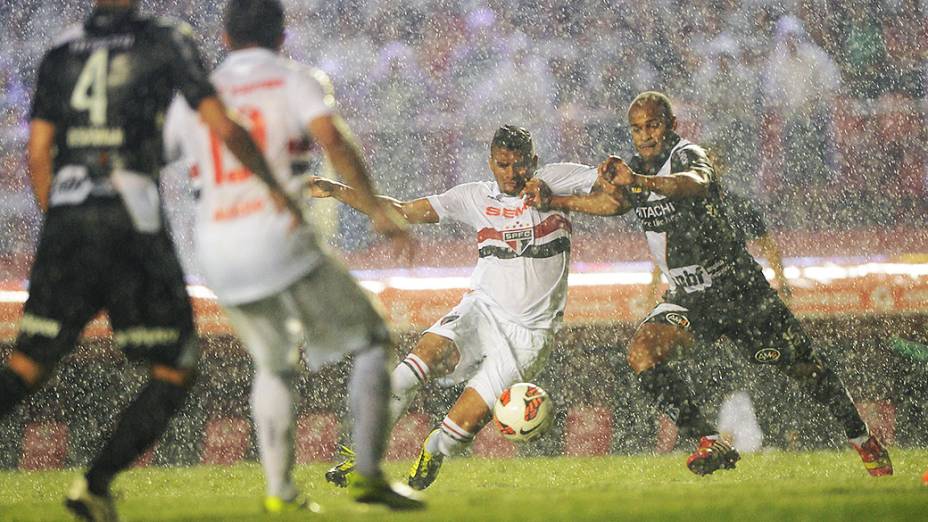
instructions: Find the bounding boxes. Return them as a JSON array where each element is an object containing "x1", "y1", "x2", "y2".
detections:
[{"x1": 86, "y1": 379, "x2": 187, "y2": 495}]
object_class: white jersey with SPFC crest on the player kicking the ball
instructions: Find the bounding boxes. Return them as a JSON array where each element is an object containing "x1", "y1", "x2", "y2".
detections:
[{"x1": 428, "y1": 163, "x2": 596, "y2": 328}]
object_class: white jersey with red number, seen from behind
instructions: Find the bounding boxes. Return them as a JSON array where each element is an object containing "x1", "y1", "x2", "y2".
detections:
[{"x1": 165, "y1": 48, "x2": 334, "y2": 305}]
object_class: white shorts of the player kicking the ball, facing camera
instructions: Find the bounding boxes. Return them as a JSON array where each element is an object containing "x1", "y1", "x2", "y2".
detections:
[{"x1": 426, "y1": 293, "x2": 554, "y2": 409}]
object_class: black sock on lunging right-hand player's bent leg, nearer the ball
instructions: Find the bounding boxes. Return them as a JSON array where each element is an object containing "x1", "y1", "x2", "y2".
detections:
[{"x1": 638, "y1": 364, "x2": 716, "y2": 437}]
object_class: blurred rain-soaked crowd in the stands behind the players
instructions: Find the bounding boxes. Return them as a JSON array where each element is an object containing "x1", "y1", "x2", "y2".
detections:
[{"x1": 0, "y1": 0, "x2": 928, "y2": 266}]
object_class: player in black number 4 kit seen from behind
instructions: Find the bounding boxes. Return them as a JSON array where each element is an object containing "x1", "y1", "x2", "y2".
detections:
[{"x1": 0, "y1": 0, "x2": 298, "y2": 520}]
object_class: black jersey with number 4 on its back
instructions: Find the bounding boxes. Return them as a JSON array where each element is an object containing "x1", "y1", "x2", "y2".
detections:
[{"x1": 32, "y1": 9, "x2": 214, "y2": 183}]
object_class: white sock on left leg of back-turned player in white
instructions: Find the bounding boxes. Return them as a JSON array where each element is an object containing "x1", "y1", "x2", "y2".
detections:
[{"x1": 251, "y1": 370, "x2": 297, "y2": 499}]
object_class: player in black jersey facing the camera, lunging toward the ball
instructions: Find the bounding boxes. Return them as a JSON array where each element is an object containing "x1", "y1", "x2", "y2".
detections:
[{"x1": 525, "y1": 92, "x2": 892, "y2": 476}]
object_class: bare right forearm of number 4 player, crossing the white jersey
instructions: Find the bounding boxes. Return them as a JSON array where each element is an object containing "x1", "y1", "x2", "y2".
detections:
[{"x1": 197, "y1": 96, "x2": 302, "y2": 219}]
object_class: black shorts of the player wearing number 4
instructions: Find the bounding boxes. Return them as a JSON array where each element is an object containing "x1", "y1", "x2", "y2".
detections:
[{"x1": 17, "y1": 199, "x2": 198, "y2": 368}]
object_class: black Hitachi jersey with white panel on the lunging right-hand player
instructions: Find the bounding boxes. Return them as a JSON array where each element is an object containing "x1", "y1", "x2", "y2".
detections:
[{"x1": 627, "y1": 138, "x2": 766, "y2": 293}]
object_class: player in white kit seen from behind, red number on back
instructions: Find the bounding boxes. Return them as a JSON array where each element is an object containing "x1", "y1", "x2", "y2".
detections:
[{"x1": 165, "y1": 0, "x2": 423, "y2": 513}]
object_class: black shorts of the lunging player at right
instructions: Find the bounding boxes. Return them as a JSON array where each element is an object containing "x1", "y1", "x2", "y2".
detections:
[{"x1": 642, "y1": 284, "x2": 813, "y2": 366}]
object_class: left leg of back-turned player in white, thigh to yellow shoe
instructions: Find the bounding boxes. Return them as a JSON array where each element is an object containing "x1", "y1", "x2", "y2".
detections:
[{"x1": 226, "y1": 295, "x2": 315, "y2": 513}]
